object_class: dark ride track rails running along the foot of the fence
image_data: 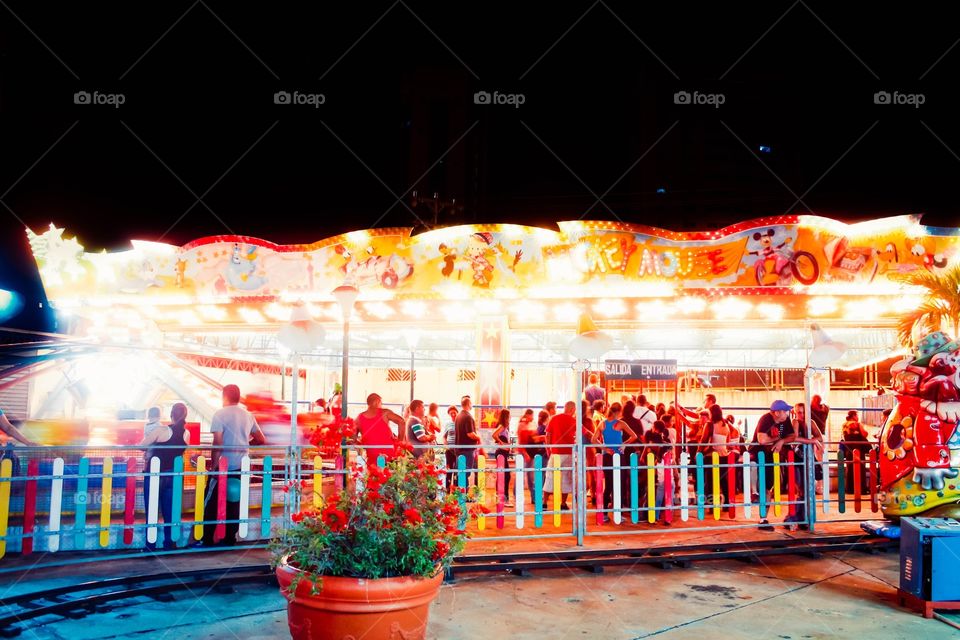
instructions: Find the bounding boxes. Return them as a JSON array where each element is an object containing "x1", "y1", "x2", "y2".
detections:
[{"x1": 0, "y1": 534, "x2": 899, "y2": 638}]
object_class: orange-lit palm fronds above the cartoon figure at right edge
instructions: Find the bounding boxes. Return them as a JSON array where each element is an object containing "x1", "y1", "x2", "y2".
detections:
[{"x1": 897, "y1": 263, "x2": 960, "y2": 347}]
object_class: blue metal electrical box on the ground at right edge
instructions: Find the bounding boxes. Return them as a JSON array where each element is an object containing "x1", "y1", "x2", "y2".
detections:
[{"x1": 900, "y1": 518, "x2": 960, "y2": 602}]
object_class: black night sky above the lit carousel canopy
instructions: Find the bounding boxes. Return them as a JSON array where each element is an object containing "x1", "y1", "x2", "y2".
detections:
[{"x1": 0, "y1": 0, "x2": 960, "y2": 328}]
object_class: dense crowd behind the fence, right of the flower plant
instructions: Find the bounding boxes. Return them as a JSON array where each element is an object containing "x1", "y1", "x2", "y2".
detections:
[{"x1": 344, "y1": 374, "x2": 884, "y2": 528}]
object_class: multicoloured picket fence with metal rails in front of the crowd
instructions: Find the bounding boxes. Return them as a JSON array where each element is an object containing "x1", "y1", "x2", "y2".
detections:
[{"x1": 0, "y1": 443, "x2": 880, "y2": 573}]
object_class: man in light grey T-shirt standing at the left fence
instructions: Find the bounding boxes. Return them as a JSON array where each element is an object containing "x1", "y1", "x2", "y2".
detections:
[{"x1": 203, "y1": 384, "x2": 266, "y2": 546}]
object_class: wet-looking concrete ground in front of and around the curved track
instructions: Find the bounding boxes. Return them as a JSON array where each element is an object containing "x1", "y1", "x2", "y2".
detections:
[{"x1": 0, "y1": 540, "x2": 960, "y2": 640}]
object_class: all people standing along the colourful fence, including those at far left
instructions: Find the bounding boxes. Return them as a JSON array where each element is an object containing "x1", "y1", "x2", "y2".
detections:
[{"x1": 0, "y1": 374, "x2": 888, "y2": 548}]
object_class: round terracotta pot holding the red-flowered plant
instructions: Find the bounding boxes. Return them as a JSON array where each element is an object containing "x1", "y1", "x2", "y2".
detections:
[{"x1": 277, "y1": 559, "x2": 443, "y2": 640}]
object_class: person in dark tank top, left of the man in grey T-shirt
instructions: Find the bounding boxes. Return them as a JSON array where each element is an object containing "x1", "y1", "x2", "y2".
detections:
[{"x1": 138, "y1": 402, "x2": 188, "y2": 551}]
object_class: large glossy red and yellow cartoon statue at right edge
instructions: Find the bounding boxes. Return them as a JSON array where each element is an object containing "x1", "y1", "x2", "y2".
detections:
[{"x1": 879, "y1": 331, "x2": 960, "y2": 517}]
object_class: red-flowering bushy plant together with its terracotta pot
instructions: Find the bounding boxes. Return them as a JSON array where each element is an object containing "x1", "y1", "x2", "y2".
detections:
[{"x1": 271, "y1": 440, "x2": 466, "y2": 640}]
